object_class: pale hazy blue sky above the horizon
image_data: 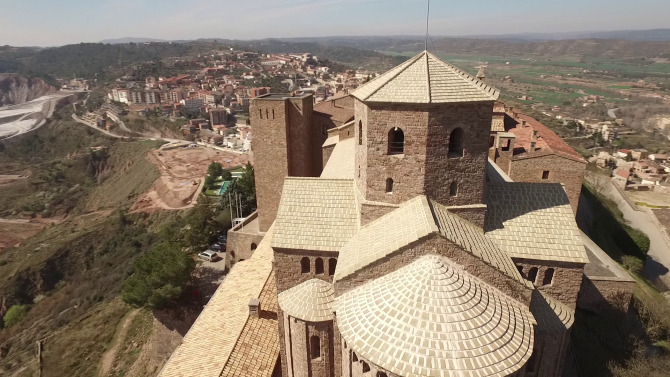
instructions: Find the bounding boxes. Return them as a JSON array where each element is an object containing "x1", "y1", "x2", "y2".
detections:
[{"x1": 0, "y1": 0, "x2": 670, "y2": 46}]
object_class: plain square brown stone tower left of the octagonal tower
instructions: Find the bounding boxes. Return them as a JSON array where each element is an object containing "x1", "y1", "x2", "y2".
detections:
[{"x1": 249, "y1": 94, "x2": 321, "y2": 232}]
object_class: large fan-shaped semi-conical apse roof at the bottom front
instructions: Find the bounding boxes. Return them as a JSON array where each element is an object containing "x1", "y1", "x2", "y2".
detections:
[{"x1": 335, "y1": 255, "x2": 535, "y2": 377}]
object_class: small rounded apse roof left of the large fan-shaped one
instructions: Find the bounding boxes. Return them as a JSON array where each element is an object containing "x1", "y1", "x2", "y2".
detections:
[{"x1": 278, "y1": 279, "x2": 335, "y2": 322}]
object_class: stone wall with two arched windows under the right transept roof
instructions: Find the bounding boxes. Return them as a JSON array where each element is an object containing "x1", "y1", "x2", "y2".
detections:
[{"x1": 512, "y1": 258, "x2": 584, "y2": 310}]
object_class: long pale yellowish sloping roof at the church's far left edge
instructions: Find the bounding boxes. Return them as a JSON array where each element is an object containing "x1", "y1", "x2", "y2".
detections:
[{"x1": 159, "y1": 227, "x2": 276, "y2": 377}]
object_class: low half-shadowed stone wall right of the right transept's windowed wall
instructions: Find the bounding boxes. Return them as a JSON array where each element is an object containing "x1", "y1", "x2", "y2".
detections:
[{"x1": 577, "y1": 276, "x2": 635, "y2": 313}]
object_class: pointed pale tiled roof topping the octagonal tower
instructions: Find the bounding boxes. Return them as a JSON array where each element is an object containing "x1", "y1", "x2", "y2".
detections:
[{"x1": 352, "y1": 51, "x2": 499, "y2": 103}]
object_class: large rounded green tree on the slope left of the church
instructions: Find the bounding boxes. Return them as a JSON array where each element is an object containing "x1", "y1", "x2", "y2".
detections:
[{"x1": 122, "y1": 243, "x2": 195, "y2": 309}]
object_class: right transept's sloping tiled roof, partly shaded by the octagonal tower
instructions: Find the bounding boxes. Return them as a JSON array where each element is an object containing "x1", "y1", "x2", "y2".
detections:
[{"x1": 485, "y1": 182, "x2": 589, "y2": 263}]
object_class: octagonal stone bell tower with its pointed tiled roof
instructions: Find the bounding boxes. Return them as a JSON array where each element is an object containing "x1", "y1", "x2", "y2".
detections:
[{"x1": 353, "y1": 51, "x2": 499, "y2": 222}]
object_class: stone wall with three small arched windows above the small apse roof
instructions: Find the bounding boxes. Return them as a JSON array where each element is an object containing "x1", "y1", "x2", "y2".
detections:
[{"x1": 273, "y1": 248, "x2": 338, "y2": 293}]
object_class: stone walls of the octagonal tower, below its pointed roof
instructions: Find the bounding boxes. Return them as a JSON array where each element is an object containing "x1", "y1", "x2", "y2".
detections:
[{"x1": 355, "y1": 100, "x2": 493, "y2": 205}]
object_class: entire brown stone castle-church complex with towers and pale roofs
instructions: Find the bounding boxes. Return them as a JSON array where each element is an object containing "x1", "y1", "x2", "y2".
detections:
[{"x1": 161, "y1": 52, "x2": 634, "y2": 377}]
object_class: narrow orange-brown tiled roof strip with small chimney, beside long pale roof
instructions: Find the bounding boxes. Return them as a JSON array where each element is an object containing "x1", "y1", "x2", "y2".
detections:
[{"x1": 221, "y1": 272, "x2": 279, "y2": 377}]
